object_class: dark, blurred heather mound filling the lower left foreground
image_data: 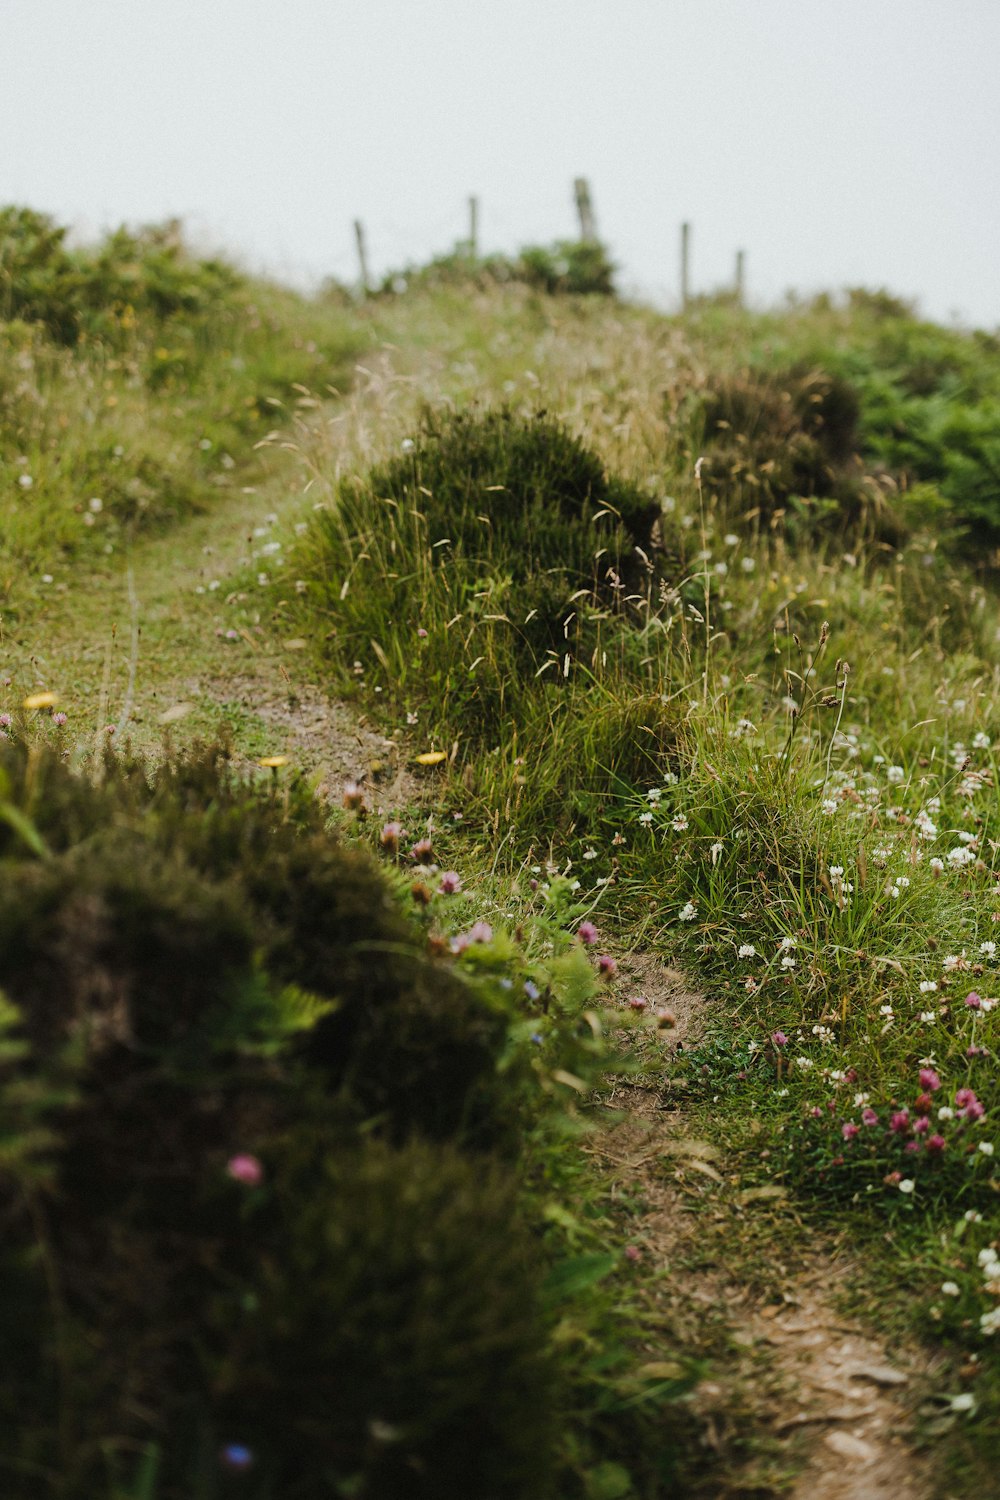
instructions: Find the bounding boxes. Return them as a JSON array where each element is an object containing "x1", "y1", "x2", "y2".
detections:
[{"x1": 0, "y1": 746, "x2": 555, "y2": 1500}]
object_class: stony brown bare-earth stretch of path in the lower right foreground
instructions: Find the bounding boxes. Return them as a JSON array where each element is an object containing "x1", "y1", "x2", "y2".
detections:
[{"x1": 592, "y1": 956, "x2": 934, "y2": 1500}]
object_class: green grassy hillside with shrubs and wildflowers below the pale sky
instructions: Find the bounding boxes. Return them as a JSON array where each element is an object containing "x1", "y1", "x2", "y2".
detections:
[{"x1": 0, "y1": 216, "x2": 1000, "y2": 1500}]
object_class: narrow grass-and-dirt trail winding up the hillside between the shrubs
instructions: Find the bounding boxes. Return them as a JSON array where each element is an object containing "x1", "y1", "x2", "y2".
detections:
[{"x1": 13, "y1": 357, "x2": 945, "y2": 1500}]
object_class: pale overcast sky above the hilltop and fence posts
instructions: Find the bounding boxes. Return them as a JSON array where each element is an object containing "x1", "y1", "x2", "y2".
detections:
[{"x1": 7, "y1": 0, "x2": 1000, "y2": 327}]
